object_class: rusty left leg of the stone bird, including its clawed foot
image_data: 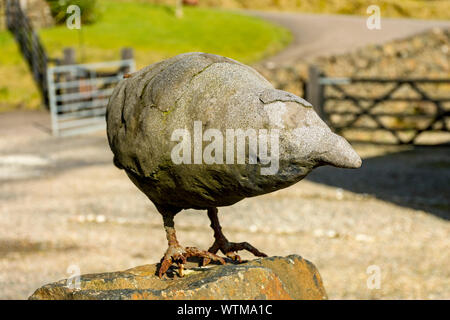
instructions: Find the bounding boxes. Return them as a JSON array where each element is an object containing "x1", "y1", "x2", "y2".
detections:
[{"x1": 158, "y1": 213, "x2": 225, "y2": 278}]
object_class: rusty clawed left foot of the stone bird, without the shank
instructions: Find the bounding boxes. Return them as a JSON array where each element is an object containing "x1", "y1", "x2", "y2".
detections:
[{"x1": 158, "y1": 245, "x2": 225, "y2": 278}]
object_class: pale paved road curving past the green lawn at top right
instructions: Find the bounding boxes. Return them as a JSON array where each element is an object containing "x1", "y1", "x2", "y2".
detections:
[{"x1": 249, "y1": 11, "x2": 450, "y2": 65}]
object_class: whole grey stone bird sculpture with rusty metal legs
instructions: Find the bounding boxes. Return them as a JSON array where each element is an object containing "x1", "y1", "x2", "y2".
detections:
[{"x1": 106, "y1": 53, "x2": 361, "y2": 277}]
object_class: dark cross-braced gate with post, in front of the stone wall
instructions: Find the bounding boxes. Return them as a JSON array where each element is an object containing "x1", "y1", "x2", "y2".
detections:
[{"x1": 307, "y1": 66, "x2": 450, "y2": 144}]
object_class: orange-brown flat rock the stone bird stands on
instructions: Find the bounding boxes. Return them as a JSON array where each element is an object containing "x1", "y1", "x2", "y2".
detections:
[{"x1": 29, "y1": 255, "x2": 327, "y2": 300}]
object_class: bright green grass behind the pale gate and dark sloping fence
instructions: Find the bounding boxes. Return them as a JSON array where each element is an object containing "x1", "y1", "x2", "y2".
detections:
[{"x1": 0, "y1": 0, "x2": 291, "y2": 111}]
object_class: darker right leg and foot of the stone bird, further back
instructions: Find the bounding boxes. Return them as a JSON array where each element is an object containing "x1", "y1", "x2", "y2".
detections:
[{"x1": 203, "y1": 208, "x2": 267, "y2": 265}]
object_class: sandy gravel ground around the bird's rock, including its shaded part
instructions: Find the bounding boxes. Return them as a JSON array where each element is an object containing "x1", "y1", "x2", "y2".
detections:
[{"x1": 0, "y1": 112, "x2": 450, "y2": 299}]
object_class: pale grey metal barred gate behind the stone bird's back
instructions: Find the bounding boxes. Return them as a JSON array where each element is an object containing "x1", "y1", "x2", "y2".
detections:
[{"x1": 47, "y1": 59, "x2": 135, "y2": 136}]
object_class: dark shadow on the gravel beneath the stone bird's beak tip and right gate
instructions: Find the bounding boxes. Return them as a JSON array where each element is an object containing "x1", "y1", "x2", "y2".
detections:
[{"x1": 307, "y1": 145, "x2": 450, "y2": 220}]
